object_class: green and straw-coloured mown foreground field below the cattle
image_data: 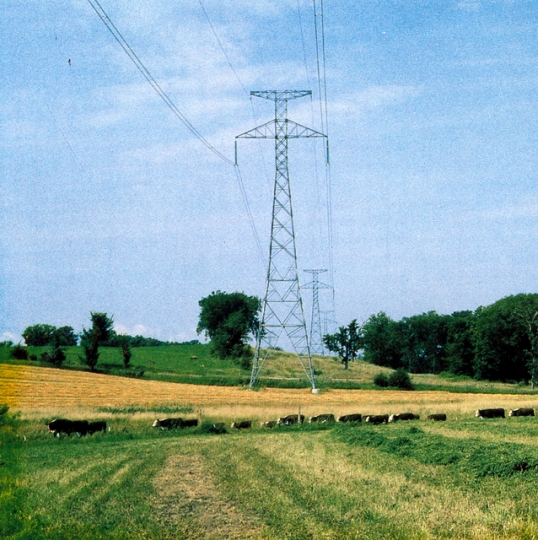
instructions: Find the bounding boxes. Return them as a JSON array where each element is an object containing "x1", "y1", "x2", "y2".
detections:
[{"x1": 5, "y1": 411, "x2": 538, "y2": 540}]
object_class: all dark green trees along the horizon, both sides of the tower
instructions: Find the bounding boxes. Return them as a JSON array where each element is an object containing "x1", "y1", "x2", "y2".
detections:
[{"x1": 9, "y1": 291, "x2": 538, "y2": 383}]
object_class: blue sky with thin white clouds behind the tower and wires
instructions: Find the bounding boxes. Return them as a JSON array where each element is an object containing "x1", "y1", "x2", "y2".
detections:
[{"x1": 0, "y1": 0, "x2": 538, "y2": 341}]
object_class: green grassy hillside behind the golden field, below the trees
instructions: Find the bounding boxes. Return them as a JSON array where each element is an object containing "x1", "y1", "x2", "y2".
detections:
[{"x1": 0, "y1": 345, "x2": 538, "y2": 395}]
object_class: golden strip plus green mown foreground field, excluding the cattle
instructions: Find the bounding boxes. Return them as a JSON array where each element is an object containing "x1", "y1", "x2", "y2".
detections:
[{"x1": 0, "y1": 364, "x2": 538, "y2": 539}]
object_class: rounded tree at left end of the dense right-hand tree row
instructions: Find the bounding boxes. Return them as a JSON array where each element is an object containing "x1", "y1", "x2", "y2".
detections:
[{"x1": 362, "y1": 311, "x2": 405, "y2": 369}]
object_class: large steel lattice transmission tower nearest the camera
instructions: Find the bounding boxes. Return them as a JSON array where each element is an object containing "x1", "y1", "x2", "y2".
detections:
[{"x1": 236, "y1": 90, "x2": 326, "y2": 392}]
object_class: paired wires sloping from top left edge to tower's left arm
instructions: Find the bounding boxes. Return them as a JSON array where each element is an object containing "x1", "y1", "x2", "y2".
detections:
[{"x1": 88, "y1": 0, "x2": 234, "y2": 165}]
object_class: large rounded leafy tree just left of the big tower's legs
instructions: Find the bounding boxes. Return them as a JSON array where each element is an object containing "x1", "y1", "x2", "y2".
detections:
[{"x1": 196, "y1": 291, "x2": 261, "y2": 368}]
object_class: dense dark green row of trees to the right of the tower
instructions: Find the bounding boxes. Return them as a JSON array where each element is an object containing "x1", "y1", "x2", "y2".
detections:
[{"x1": 340, "y1": 294, "x2": 538, "y2": 383}]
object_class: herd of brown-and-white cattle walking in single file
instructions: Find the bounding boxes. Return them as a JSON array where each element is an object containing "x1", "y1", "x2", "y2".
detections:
[{"x1": 47, "y1": 408, "x2": 534, "y2": 437}]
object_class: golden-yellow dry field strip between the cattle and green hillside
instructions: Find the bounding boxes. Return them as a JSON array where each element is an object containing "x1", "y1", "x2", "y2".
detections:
[{"x1": 0, "y1": 364, "x2": 538, "y2": 420}]
